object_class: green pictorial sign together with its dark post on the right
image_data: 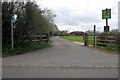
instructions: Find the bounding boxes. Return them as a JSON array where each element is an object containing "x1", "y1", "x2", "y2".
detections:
[{"x1": 102, "y1": 8, "x2": 111, "y2": 32}]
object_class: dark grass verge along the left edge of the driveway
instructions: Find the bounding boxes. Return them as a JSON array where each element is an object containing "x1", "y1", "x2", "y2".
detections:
[{"x1": 2, "y1": 41, "x2": 51, "y2": 57}]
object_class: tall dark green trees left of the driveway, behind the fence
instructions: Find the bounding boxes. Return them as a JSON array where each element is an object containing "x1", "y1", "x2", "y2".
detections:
[{"x1": 2, "y1": 2, "x2": 58, "y2": 47}]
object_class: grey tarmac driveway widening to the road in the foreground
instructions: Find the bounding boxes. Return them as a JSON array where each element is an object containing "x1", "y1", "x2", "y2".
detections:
[{"x1": 2, "y1": 37, "x2": 118, "y2": 78}]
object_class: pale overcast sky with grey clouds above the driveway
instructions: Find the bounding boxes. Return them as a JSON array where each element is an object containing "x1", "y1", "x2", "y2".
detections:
[{"x1": 36, "y1": 0, "x2": 120, "y2": 32}]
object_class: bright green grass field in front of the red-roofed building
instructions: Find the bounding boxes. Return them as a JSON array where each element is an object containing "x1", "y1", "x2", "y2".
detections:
[{"x1": 59, "y1": 36, "x2": 84, "y2": 42}]
